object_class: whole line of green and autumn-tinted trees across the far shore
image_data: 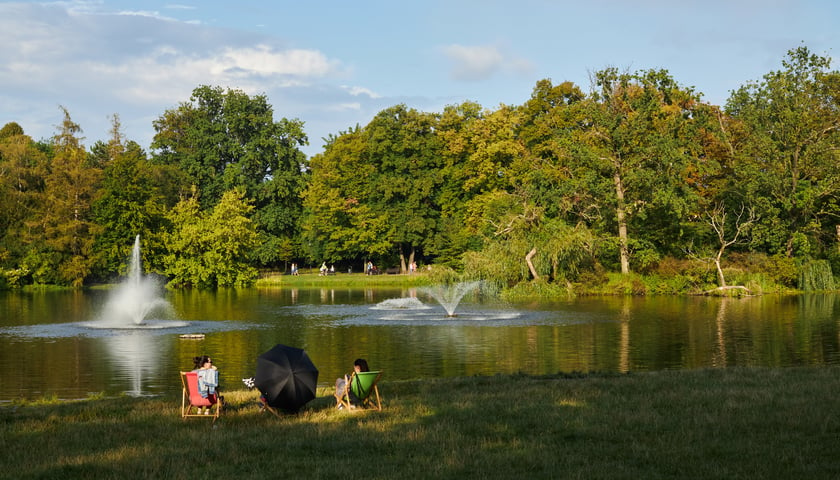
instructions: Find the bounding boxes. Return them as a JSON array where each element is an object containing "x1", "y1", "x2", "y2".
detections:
[{"x1": 0, "y1": 46, "x2": 840, "y2": 289}]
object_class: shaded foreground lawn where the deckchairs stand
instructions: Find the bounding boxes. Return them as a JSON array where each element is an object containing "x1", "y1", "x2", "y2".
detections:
[{"x1": 0, "y1": 367, "x2": 840, "y2": 479}]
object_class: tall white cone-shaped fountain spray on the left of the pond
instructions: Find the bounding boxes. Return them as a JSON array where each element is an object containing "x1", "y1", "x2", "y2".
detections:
[{"x1": 87, "y1": 235, "x2": 187, "y2": 328}]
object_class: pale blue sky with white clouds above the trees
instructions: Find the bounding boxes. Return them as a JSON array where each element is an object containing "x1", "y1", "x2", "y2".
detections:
[{"x1": 0, "y1": 0, "x2": 840, "y2": 156}]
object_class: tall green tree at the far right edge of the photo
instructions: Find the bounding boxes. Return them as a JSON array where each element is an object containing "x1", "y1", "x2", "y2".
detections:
[{"x1": 726, "y1": 46, "x2": 840, "y2": 257}]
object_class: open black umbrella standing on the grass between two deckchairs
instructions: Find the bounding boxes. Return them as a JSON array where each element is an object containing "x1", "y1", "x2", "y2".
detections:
[{"x1": 254, "y1": 344, "x2": 318, "y2": 412}]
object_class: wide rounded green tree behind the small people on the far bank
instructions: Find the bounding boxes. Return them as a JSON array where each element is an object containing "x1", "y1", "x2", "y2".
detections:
[{"x1": 304, "y1": 105, "x2": 440, "y2": 269}]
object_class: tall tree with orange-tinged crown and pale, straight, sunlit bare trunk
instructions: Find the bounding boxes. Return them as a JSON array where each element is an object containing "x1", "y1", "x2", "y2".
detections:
[{"x1": 586, "y1": 68, "x2": 706, "y2": 274}]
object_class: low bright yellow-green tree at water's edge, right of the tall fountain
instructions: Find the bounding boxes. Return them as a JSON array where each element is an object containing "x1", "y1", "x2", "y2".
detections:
[{"x1": 163, "y1": 190, "x2": 257, "y2": 288}]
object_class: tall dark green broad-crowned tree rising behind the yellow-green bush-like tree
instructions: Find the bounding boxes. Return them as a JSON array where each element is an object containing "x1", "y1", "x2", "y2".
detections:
[{"x1": 152, "y1": 86, "x2": 308, "y2": 263}]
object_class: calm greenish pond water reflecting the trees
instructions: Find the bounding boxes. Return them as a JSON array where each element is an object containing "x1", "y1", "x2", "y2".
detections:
[{"x1": 0, "y1": 288, "x2": 840, "y2": 402}]
